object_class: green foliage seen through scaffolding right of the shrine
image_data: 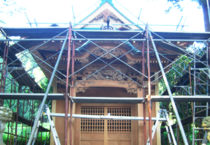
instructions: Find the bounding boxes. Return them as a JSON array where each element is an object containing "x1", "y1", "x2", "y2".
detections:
[{"x1": 159, "y1": 42, "x2": 206, "y2": 144}]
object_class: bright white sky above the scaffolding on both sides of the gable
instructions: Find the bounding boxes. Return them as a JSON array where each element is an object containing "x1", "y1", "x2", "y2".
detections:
[{"x1": 0, "y1": 0, "x2": 204, "y2": 32}]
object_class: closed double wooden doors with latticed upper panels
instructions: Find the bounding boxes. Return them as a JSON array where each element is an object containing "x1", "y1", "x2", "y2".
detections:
[{"x1": 80, "y1": 105, "x2": 131, "y2": 145}]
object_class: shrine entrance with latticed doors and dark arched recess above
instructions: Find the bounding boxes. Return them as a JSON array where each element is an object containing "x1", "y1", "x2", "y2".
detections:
[{"x1": 76, "y1": 87, "x2": 137, "y2": 145}]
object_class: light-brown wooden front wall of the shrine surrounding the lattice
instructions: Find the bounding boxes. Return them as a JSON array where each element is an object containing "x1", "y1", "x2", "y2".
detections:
[{"x1": 55, "y1": 87, "x2": 157, "y2": 145}]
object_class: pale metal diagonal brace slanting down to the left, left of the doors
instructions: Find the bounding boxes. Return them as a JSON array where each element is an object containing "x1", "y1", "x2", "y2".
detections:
[{"x1": 27, "y1": 28, "x2": 69, "y2": 145}]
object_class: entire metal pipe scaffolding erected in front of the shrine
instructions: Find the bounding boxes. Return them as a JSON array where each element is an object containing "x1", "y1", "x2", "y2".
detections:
[{"x1": 0, "y1": 26, "x2": 210, "y2": 145}]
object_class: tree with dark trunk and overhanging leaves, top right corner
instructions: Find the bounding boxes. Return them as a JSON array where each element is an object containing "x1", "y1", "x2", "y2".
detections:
[{"x1": 168, "y1": 0, "x2": 210, "y2": 32}]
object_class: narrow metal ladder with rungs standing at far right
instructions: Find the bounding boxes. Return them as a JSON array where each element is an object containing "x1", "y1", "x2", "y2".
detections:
[{"x1": 192, "y1": 46, "x2": 209, "y2": 145}]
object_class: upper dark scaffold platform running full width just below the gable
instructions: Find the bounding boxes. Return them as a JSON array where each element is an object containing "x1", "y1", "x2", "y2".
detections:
[{"x1": 3, "y1": 28, "x2": 210, "y2": 41}]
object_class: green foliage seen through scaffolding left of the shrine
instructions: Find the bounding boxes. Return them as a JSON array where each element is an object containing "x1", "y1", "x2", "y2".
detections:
[{"x1": 0, "y1": 44, "x2": 53, "y2": 145}]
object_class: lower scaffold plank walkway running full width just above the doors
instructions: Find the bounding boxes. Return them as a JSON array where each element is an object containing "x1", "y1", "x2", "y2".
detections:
[{"x1": 0, "y1": 93, "x2": 210, "y2": 101}]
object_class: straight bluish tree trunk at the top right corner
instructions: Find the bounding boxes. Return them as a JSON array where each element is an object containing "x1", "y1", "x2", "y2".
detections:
[{"x1": 201, "y1": 0, "x2": 210, "y2": 32}]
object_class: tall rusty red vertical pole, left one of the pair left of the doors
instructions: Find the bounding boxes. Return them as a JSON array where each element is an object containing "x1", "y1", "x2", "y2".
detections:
[{"x1": 64, "y1": 25, "x2": 72, "y2": 145}]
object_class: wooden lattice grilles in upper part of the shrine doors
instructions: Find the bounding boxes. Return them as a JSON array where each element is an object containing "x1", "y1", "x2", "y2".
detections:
[{"x1": 81, "y1": 106, "x2": 131, "y2": 132}]
